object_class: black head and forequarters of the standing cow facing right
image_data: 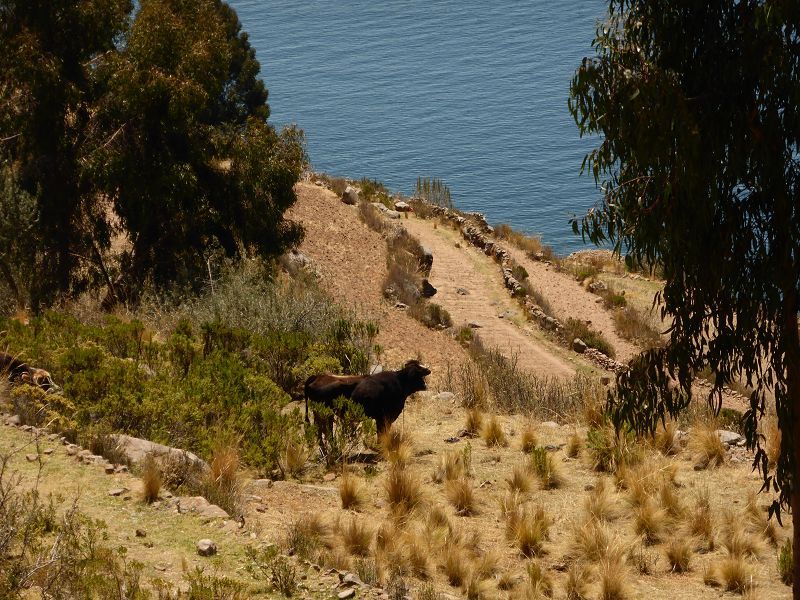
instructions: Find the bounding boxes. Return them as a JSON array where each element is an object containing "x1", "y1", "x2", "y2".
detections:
[{"x1": 350, "y1": 360, "x2": 431, "y2": 435}]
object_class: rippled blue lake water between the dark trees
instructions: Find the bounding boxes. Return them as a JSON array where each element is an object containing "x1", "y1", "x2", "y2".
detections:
[{"x1": 228, "y1": 0, "x2": 607, "y2": 253}]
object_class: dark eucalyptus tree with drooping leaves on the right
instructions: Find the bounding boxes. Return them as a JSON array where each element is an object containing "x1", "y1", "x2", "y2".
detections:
[{"x1": 569, "y1": 0, "x2": 800, "y2": 598}]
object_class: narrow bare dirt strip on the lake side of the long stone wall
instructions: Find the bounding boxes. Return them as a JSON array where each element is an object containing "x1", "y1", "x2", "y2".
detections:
[{"x1": 504, "y1": 244, "x2": 640, "y2": 363}]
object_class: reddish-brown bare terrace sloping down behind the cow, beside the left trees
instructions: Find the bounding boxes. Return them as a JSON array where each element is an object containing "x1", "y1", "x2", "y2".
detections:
[{"x1": 287, "y1": 183, "x2": 466, "y2": 382}]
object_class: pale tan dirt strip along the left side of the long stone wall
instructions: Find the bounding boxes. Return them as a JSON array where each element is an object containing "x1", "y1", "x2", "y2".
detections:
[{"x1": 403, "y1": 216, "x2": 578, "y2": 377}]
